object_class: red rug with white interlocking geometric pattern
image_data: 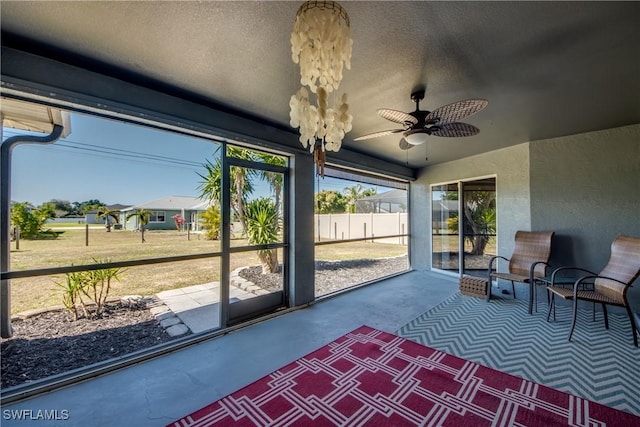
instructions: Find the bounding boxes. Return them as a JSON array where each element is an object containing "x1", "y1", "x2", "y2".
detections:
[{"x1": 171, "y1": 326, "x2": 640, "y2": 427}]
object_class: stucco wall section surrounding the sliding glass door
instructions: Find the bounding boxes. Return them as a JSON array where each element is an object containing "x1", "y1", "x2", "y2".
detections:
[{"x1": 410, "y1": 144, "x2": 532, "y2": 270}]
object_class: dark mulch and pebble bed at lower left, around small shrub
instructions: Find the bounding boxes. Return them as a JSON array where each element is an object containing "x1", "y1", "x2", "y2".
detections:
[{"x1": 0, "y1": 302, "x2": 172, "y2": 389}]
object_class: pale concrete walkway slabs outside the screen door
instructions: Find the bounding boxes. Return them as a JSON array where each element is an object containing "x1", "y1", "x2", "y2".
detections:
[{"x1": 152, "y1": 282, "x2": 256, "y2": 335}]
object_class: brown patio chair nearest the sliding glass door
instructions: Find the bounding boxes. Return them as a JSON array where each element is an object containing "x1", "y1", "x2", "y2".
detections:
[{"x1": 487, "y1": 231, "x2": 554, "y2": 314}]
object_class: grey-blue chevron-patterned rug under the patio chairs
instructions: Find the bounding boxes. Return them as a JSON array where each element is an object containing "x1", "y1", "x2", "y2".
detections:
[{"x1": 396, "y1": 294, "x2": 640, "y2": 415}]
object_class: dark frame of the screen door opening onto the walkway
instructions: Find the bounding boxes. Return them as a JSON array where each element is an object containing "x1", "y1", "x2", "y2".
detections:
[{"x1": 220, "y1": 143, "x2": 290, "y2": 328}]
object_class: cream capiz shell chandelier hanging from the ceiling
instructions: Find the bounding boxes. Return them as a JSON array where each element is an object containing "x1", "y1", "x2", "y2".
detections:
[{"x1": 289, "y1": 1, "x2": 353, "y2": 175}]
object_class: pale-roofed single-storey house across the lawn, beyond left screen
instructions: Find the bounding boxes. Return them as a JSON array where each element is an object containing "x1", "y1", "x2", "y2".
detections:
[{"x1": 120, "y1": 196, "x2": 210, "y2": 231}]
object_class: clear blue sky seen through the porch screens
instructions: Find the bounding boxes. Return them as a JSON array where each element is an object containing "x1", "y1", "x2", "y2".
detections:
[{"x1": 3, "y1": 113, "x2": 380, "y2": 206}]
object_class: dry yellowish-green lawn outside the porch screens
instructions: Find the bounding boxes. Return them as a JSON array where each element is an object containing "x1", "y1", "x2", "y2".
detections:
[{"x1": 11, "y1": 226, "x2": 407, "y2": 314}]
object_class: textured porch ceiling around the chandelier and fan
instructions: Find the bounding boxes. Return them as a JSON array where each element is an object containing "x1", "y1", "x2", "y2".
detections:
[{"x1": 0, "y1": 0, "x2": 640, "y2": 167}]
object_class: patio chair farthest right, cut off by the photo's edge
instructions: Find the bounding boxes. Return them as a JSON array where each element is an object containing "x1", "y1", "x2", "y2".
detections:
[{"x1": 547, "y1": 235, "x2": 640, "y2": 347}]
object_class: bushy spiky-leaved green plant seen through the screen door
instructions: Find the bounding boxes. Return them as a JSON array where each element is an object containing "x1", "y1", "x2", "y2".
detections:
[{"x1": 246, "y1": 197, "x2": 280, "y2": 274}]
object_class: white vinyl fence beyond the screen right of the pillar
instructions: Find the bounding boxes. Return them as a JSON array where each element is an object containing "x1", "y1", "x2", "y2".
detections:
[{"x1": 315, "y1": 212, "x2": 409, "y2": 245}]
